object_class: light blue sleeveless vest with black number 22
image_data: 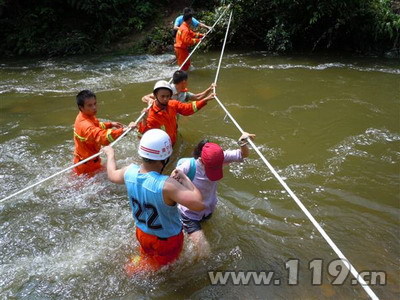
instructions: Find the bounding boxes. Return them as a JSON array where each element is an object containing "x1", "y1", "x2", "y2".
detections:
[{"x1": 124, "y1": 164, "x2": 182, "y2": 238}]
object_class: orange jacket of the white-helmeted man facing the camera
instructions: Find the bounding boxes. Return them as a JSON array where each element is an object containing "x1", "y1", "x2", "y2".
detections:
[{"x1": 138, "y1": 100, "x2": 207, "y2": 145}]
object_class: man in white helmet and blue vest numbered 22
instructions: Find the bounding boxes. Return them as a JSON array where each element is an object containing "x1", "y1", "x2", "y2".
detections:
[{"x1": 103, "y1": 129, "x2": 205, "y2": 276}]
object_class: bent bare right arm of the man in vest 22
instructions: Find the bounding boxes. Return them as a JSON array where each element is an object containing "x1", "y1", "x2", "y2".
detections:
[{"x1": 163, "y1": 170, "x2": 205, "y2": 211}]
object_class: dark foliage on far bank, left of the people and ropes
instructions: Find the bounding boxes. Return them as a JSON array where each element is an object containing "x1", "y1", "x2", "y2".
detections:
[{"x1": 0, "y1": 0, "x2": 168, "y2": 55}]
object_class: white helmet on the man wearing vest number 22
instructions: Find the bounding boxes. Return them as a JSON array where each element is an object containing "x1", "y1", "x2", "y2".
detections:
[{"x1": 138, "y1": 129, "x2": 172, "y2": 160}]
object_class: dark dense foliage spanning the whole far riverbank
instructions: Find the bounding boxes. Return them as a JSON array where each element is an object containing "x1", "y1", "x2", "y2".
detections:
[{"x1": 0, "y1": 0, "x2": 400, "y2": 56}]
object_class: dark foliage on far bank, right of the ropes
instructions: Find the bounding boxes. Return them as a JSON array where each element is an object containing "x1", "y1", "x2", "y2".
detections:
[{"x1": 197, "y1": 0, "x2": 400, "y2": 55}]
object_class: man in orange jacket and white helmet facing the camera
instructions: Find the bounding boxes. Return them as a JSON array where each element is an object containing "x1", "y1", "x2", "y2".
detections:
[{"x1": 137, "y1": 80, "x2": 215, "y2": 145}]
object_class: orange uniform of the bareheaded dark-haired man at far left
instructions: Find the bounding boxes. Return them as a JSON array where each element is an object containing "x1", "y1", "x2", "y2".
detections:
[{"x1": 74, "y1": 112, "x2": 123, "y2": 175}]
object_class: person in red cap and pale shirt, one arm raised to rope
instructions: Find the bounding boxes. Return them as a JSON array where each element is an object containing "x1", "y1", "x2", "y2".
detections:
[{"x1": 171, "y1": 132, "x2": 255, "y2": 258}]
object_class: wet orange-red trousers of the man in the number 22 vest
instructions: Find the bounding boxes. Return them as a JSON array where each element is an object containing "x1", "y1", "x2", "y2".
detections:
[{"x1": 125, "y1": 227, "x2": 183, "y2": 276}]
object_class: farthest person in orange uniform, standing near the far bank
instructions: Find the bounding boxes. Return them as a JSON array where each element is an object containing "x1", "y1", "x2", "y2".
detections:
[{"x1": 174, "y1": 13, "x2": 204, "y2": 71}]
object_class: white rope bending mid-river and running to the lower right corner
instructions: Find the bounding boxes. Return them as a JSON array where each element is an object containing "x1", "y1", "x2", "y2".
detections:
[{"x1": 214, "y1": 7, "x2": 379, "y2": 300}]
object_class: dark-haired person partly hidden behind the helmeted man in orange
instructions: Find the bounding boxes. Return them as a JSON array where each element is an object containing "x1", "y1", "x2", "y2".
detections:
[{"x1": 142, "y1": 70, "x2": 216, "y2": 104}]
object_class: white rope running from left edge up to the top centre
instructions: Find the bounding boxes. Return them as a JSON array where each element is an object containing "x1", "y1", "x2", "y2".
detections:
[{"x1": 0, "y1": 4, "x2": 230, "y2": 203}]
